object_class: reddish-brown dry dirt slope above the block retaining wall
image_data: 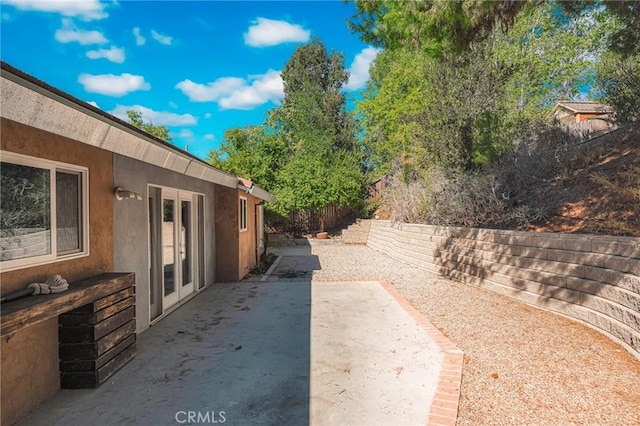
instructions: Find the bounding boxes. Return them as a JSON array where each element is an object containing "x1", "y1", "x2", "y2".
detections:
[{"x1": 526, "y1": 126, "x2": 640, "y2": 237}]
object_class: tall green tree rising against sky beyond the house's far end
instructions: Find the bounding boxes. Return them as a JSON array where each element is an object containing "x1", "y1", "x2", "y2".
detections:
[{"x1": 271, "y1": 39, "x2": 364, "y2": 230}]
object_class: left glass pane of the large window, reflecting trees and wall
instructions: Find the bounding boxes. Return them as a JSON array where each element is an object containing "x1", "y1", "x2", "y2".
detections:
[{"x1": 0, "y1": 162, "x2": 51, "y2": 261}]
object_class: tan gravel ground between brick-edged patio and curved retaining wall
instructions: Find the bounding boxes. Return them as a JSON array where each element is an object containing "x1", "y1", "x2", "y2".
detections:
[{"x1": 304, "y1": 242, "x2": 640, "y2": 425}]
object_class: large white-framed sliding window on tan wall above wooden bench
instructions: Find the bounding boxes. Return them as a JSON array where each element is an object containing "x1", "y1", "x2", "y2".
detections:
[{"x1": 0, "y1": 152, "x2": 89, "y2": 271}]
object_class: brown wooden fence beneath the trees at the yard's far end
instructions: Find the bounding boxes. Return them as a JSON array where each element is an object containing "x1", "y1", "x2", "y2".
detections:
[{"x1": 265, "y1": 204, "x2": 356, "y2": 234}]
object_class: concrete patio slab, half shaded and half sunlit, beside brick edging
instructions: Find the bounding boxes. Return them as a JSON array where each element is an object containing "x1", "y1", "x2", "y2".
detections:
[{"x1": 20, "y1": 280, "x2": 443, "y2": 425}]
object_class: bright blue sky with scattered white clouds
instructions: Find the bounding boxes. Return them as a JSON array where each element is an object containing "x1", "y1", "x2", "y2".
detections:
[{"x1": 0, "y1": 0, "x2": 377, "y2": 158}]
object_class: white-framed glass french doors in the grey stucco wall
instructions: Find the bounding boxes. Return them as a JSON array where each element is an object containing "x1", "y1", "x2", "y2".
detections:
[{"x1": 149, "y1": 186, "x2": 204, "y2": 320}]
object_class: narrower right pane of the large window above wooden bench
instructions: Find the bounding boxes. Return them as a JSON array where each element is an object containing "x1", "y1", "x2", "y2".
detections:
[{"x1": 56, "y1": 172, "x2": 82, "y2": 254}]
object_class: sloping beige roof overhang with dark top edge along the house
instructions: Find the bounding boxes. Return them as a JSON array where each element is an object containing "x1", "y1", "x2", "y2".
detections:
[{"x1": 0, "y1": 61, "x2": 271, "y2": 201}]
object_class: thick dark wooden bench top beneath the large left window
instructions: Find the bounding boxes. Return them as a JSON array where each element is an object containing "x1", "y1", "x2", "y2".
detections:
[{"x1": 0, "y1": 272, "x2": 135, "y2": 337}]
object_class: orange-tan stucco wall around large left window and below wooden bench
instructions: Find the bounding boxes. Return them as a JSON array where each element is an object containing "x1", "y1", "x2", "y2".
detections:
[{"x1": 0, "y1": 118, "x2": 113, "y2": 425}]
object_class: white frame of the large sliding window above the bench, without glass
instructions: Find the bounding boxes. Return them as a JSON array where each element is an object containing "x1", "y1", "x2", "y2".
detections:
[{"x1": 0, "y1": 151, "x2": 90, "y2": 272}]
